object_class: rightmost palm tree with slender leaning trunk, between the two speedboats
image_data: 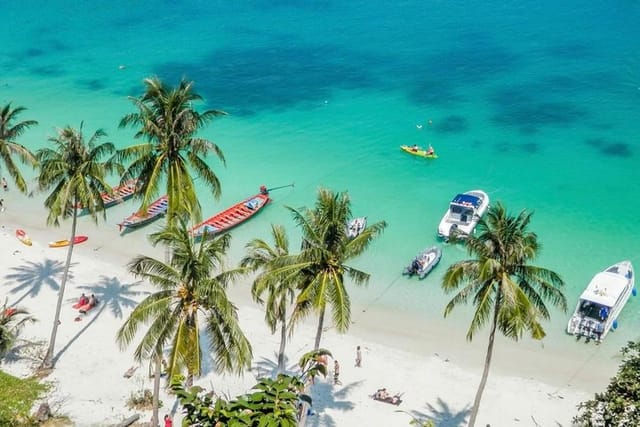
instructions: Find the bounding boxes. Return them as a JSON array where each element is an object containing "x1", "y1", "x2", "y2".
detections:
[{"x1": 442, "y1": 203, "x2": 567, "y2": 427}]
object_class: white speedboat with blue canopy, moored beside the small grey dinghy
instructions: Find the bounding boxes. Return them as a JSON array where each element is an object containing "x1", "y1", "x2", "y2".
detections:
[{"x1": 438, "y1": 190, "x2": 489, "y2": 239}]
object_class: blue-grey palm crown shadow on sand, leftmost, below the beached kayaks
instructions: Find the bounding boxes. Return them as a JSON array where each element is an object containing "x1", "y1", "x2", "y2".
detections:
[{"x1": 5, "y1": 258, "x2": 74, "y2": 306}]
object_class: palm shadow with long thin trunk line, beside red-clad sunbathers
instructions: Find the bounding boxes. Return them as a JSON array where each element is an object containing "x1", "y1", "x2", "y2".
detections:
[{"x1": 54, "y1": 276, "x2": 143, "y2": 362}]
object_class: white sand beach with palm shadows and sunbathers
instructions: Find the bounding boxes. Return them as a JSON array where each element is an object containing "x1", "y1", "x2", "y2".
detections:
[{"x1": 0, "y1": 199, "x2": 614, "y2": 427}]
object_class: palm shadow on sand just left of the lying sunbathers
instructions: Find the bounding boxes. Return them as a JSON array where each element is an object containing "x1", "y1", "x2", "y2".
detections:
[{"x1": 306, "y1": 382, "x2": 363, "y2": 427}]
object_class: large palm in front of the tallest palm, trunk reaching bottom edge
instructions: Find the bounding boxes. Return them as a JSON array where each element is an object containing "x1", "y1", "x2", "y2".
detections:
[{"x1": 117, "y1": 218, "x2": 252, "y2": 425}]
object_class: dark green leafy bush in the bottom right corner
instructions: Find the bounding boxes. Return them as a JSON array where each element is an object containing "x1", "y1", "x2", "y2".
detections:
[{"x1": 573, "y1": 341, "x2": 640, "y2": 427}]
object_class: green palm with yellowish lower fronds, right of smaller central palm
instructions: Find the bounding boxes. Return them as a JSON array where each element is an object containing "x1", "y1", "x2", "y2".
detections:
[{"x1": 288, "y1": 188, "x2": 387, "y2": 350}]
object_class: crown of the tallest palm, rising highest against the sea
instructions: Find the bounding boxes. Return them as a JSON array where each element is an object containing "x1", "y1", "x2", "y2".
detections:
[{"x1": 115, "y1": 77, "x2": 226, "y2": 223}]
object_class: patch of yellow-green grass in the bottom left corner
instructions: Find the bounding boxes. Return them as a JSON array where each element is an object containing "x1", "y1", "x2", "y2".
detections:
[{"x1": 0, "y1": 371, "x2": 48, "y2": 426}]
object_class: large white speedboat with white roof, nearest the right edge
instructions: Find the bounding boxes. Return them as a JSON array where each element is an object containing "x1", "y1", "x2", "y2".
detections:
[{"x1": 567, "y1": 261, "x2": 634, "y2": 341}]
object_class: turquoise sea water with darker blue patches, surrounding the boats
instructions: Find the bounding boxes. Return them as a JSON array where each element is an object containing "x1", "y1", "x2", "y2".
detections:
[{"x1": 0, "y1": 0, "x2": 640, "y2": 378}]
